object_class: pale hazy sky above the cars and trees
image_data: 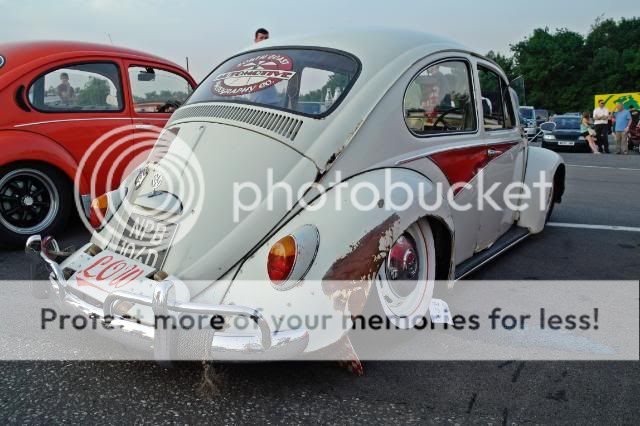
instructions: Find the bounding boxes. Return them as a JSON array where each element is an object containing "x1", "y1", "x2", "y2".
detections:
[{"x1": 0, "y1": 0, "x2": 640, "y2": 81}]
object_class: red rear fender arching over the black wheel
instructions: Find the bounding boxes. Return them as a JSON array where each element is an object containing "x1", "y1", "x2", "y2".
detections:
[{"x1": 0, "y1": 130, "x2": 90, "y2": 194}]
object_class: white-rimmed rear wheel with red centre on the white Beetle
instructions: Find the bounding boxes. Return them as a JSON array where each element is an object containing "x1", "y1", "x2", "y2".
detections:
[{"x1": 376, "y1": 220, "x2": 436, "y2": 329}]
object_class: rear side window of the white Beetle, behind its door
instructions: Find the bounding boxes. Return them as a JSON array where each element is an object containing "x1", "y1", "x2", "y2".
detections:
[{"x1": 404, "y1": 61, "x2": 477, "y2": 136}]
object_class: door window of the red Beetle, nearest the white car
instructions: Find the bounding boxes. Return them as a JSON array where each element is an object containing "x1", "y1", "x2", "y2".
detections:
[{"x1": 129, "y1": 66, "x2": 193, "y2": 113}]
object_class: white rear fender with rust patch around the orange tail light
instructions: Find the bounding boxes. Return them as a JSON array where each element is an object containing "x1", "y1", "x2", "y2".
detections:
[{"x1": 218, "y1": 168, "x2": 453, "y2": 351}]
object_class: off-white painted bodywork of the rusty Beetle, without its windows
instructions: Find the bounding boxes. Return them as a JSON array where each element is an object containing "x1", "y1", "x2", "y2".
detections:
[{"x1": 28, "y1": 30, "x2": 564, "y2": 359}]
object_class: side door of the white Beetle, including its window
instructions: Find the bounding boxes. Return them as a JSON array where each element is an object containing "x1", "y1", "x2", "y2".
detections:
[{"x1": 475, "y1": 60, "x2": 526, "y2": 252}]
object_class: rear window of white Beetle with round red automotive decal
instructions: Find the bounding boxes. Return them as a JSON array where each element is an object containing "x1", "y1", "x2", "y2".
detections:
[{"x1": 187, "y1": 49, "x2": 359, "y2": 116}]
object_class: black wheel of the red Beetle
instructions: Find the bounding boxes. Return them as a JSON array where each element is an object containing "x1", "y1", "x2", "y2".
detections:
[{"x1": 0, "y1": 163, "x2": 74, "y2": 247}]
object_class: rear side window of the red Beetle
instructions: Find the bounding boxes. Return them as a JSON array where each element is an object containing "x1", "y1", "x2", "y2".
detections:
[{"x1": 28, "y1": 63, "x2": 124, "y2": 112}]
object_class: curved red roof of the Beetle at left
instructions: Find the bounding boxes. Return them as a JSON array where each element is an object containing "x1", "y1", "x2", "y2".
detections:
[{"x1": 0, "y1": 41, "x2": 186, "y2": 88}]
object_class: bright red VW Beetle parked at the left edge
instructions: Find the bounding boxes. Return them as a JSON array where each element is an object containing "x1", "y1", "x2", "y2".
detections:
[{"x1": 0, "y1": 42, "x2": 196, "y2": 245}]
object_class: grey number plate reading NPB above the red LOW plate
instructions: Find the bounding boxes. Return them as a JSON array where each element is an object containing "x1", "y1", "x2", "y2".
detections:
[{"x1": 109, "y1": 213, "x2": 177, "y2": 270}]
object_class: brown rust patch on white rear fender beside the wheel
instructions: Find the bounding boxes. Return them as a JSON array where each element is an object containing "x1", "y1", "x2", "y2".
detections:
[{"x1": 322, "y1": 213, "x2": 400, "y2": 315}]
